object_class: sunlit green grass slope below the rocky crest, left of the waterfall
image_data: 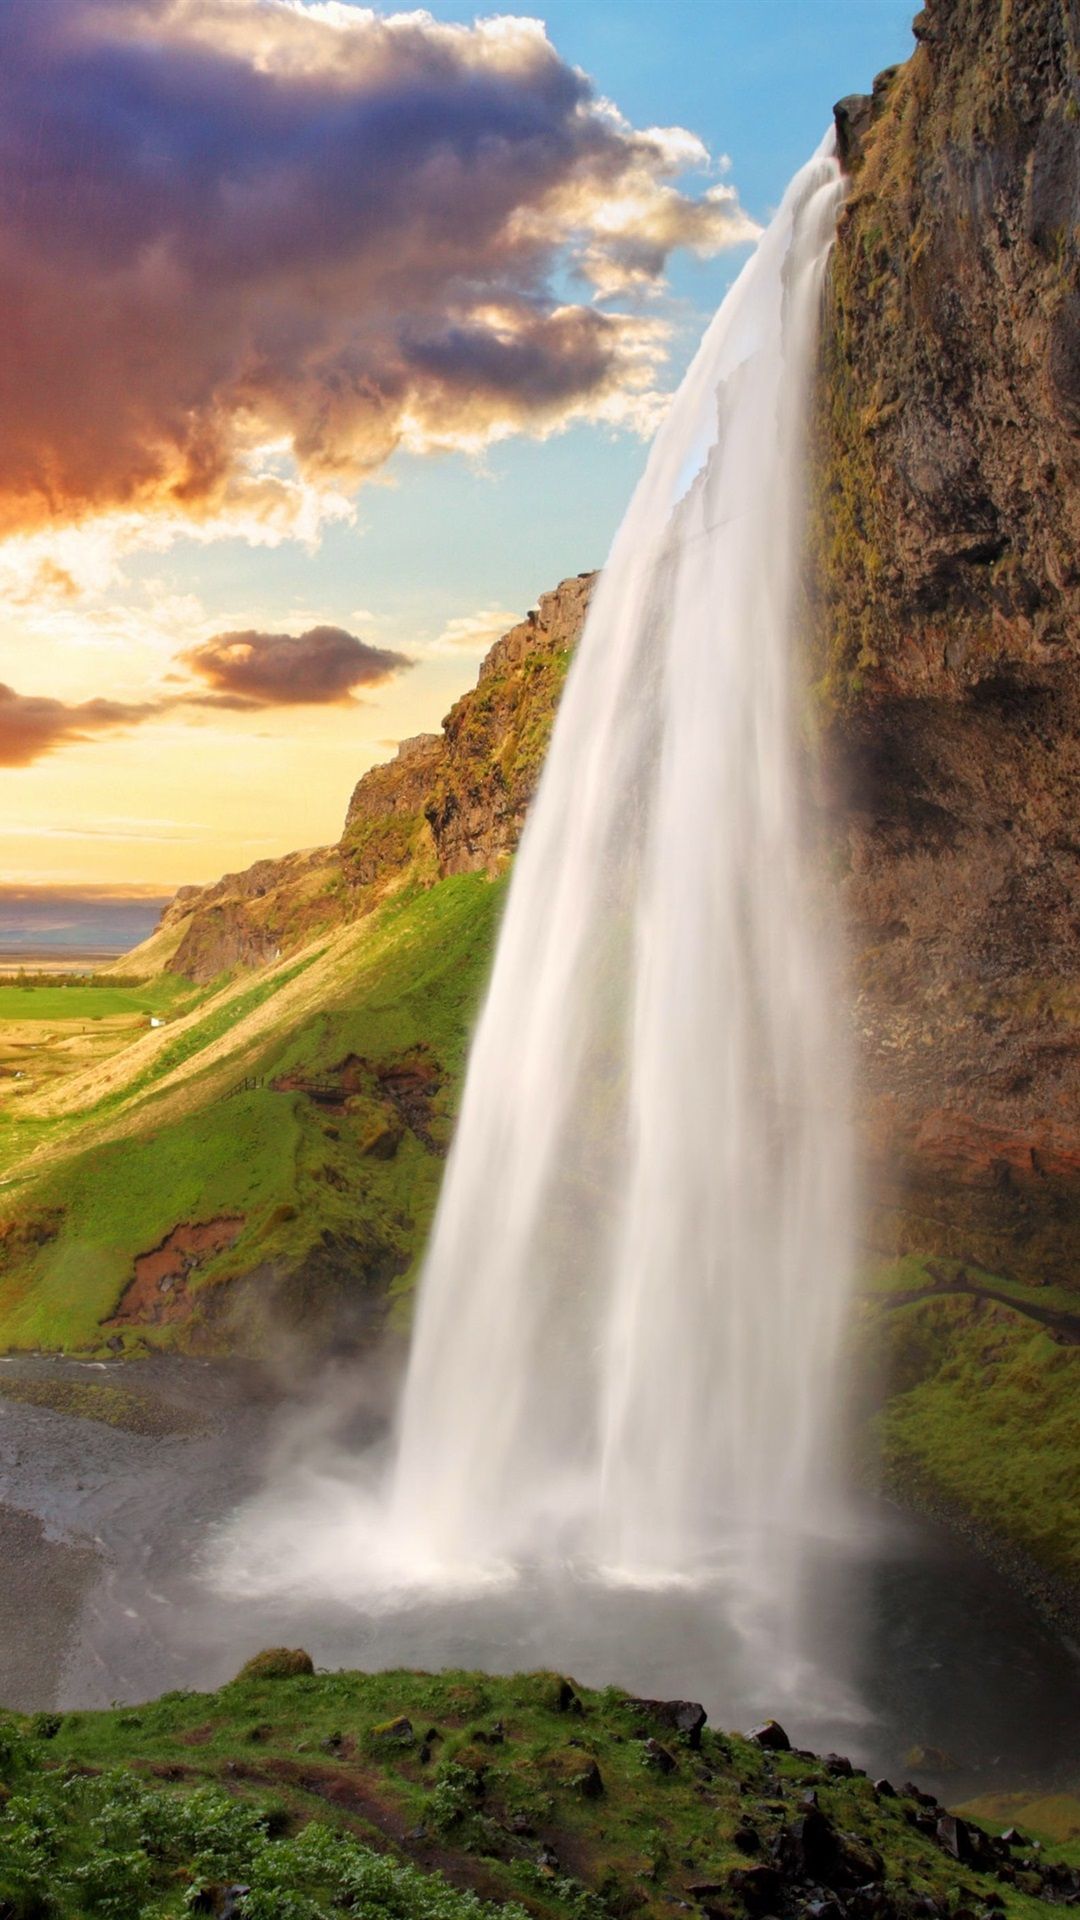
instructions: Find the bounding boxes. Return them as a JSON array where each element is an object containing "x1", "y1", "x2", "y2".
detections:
[{"x1": 0, "y1": 876, "x2": 502, "y2": 1350}]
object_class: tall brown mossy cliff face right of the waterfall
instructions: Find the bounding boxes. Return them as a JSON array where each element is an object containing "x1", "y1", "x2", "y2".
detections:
[{"x1": 811, "y1": 0, "x2": 1080, "y2": 1284}]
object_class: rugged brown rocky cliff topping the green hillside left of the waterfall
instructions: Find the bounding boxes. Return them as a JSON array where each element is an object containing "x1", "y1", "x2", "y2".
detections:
[{"x1": 147, "y1": 574, "x2": 596, "y2": 983}]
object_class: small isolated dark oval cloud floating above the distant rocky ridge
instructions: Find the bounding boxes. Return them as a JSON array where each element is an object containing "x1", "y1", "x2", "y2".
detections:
[{"x1": 181, "y1": 626, "x2": 413, "y2": 710}]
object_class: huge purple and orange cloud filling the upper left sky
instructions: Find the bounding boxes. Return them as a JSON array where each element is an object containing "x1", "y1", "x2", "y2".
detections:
[{"x1": 0, "y1": 0, "x2": 755, "y2": 538}]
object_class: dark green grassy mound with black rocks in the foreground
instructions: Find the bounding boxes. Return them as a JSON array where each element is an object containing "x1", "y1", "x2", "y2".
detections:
[{"x1": 0, "y1": 1663, "x2": 1080, "y2": 1920}]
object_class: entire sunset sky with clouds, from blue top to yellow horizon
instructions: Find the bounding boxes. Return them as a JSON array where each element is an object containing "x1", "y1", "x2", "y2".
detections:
[{"x1": 0, "y1": 0, "x2": 913, "y2": 921}]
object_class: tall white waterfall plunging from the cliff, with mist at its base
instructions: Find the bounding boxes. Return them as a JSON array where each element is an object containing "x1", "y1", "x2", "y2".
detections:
[{"x1": 209, "y1": 140, "x2": 857, "y2": 1724}]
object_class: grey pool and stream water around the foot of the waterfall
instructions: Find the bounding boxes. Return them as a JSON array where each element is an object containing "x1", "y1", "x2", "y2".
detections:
[{"x1": 0, "y1": 1357, "x2": 1080, "y2": 1803}]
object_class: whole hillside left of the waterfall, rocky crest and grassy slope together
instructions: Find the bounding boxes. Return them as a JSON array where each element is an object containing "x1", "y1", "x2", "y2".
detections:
[{"x1": 0, "y1": 576, "x2": 592, "y2": 1352}]
